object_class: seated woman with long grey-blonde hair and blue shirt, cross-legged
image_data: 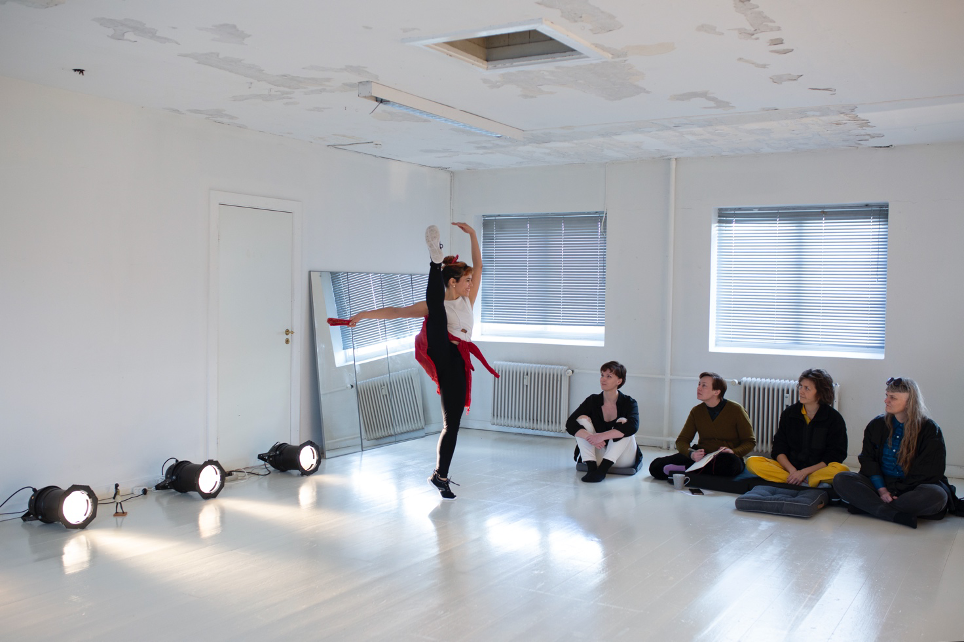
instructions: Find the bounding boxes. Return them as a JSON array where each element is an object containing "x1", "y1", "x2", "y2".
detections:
[{"x1": 833, "y1": 377, "x2": 948, "y2": 528}]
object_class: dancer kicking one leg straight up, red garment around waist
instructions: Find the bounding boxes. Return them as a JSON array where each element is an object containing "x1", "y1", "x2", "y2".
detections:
[{"x1": 348, "y1": 223, "x2": 499, "y2": 499}]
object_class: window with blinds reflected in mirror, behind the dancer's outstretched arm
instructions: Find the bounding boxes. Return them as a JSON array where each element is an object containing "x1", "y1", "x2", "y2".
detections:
[{"x1": 331, "y1": 272, "x2": 428, "y2": 348}]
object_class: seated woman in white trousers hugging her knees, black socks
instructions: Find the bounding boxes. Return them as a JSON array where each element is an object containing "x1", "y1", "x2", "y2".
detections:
[{"x1": 566, "y1": 361, "x2": 642, "y2": 482}]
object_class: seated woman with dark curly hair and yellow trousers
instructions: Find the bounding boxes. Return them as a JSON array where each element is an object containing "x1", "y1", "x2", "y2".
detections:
[{"x1": 746, "y1": 369, "x2": 850, "y2": 487}]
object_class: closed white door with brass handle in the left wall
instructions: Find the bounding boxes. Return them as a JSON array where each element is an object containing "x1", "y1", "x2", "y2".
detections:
[{"x1": 217, "y1": 205, "x2": 294, "y2": 468}]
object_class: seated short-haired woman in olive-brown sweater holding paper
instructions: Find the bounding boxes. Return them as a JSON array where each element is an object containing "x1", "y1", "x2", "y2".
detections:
[{"x1": 649, "y1": 372, "x2": 756, "y2": 479}]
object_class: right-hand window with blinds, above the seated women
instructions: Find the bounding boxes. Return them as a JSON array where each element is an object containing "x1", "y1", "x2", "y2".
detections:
[{"x1": 710, "y1": 203, "x2": 888, "y2": 359}]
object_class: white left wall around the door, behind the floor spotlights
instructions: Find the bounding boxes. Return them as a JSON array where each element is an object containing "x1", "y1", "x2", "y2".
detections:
[{"x1": 0, "y1": 78, "x2": 451, "y2": 491}]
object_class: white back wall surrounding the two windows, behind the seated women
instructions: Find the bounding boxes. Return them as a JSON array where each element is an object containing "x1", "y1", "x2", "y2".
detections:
[{"x1": 453, "y1": 144, "x2": 964, "y2": 475}]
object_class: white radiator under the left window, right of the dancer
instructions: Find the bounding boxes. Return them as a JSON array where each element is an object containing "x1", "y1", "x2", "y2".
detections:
[{"x1": 492, "y1": 361, "x2": 572, "y2": 432}]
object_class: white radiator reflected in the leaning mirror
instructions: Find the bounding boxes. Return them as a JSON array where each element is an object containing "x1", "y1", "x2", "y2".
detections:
[{"x1": 358, "y1": 368, "x2": 425, "y2": 440}]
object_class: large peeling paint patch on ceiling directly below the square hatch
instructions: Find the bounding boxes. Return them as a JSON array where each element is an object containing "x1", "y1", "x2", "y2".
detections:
[{"x1": 482, "y1": 61, "x2": 649, "y2": 100}]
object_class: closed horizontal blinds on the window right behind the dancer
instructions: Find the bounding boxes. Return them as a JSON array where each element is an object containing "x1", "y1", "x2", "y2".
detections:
[{"x1": 482, "y1": 212, "x2": 606, "y2": 326}]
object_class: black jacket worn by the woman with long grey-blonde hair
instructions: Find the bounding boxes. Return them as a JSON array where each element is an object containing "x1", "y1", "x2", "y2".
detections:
[{"x1": 858, "y1": 415, "x2": 947, "y2": 494}]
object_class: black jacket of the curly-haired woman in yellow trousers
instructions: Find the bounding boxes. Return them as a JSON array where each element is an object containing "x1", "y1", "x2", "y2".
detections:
[{"x1": 770, "y1": 401, "x2": 847, "y2": 470}]
